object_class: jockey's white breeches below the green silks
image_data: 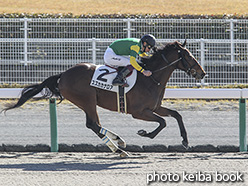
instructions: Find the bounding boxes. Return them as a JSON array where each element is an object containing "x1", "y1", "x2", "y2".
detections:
[{"x1": 104, "y1": 47, "x2": 130, "y2": 67}]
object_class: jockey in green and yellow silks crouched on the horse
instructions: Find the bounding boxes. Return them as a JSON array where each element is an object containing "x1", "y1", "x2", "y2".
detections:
[{"x1": 104, "y1": 34, "x2": 156, "y2": 87}]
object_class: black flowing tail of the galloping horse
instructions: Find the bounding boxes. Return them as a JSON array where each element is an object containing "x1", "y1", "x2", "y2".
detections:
[{"x1": 2, "y1": 74, "x2": 63, "y2": 111}]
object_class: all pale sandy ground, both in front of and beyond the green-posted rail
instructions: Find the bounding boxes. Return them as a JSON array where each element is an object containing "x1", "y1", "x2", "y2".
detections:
[{"x1": 0, "y1": 100, "x2": 248, "y2": 186}]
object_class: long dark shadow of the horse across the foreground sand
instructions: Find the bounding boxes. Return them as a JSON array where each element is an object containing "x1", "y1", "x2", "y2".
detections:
[{"x1": 0, "y1": 162, "x2": 140, "y2": 171}]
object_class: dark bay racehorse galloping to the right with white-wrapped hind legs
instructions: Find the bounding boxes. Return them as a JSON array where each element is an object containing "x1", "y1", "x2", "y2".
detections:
[{"x1": 4, "y1": 40, "x2": 206, "y2": 157}]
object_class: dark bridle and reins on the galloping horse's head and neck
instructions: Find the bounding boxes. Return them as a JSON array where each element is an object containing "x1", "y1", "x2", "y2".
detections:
[{"x1": 150, "y1": 49, "x2": 199, "y2": 86}]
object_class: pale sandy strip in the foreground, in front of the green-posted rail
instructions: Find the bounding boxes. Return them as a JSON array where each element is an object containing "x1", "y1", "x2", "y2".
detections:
[{"x1": 0, "y1": 153, "x2": 248, "y2": 186}]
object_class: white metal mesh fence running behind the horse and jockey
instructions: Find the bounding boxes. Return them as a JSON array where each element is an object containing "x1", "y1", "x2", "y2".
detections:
[{"x1": 0, "y1": 18, "x2": 248, "y2": 87}]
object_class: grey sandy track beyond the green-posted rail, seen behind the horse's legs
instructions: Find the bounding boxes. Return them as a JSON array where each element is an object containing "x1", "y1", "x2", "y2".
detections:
[{"x1": 0, "y1": 100, "x2": 244, "y2": 146}]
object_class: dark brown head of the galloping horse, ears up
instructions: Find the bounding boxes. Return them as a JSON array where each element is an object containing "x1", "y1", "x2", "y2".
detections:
[{"x1": 175, "y1": 40, "x2": 206, "y2": 80}]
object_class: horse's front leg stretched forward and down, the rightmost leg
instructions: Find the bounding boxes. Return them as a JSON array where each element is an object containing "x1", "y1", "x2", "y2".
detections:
[{"x1": 154, "y1": 106, "x2": 188, "y2": 148}]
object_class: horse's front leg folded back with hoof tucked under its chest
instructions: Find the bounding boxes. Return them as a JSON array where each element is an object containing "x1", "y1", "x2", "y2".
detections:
[{"x1": 132, "y1": 109, "x2": 166, "y2": 139}]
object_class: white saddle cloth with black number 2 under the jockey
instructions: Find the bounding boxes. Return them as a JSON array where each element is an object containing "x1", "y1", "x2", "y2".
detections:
[{"x1": 90, "y1": 65, "x2": 137, "y2": 93}]
